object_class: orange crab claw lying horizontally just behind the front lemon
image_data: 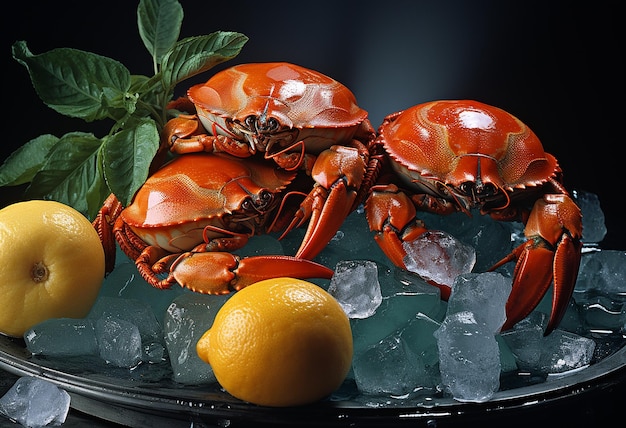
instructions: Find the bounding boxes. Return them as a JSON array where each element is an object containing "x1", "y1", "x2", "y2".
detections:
[{"x1": 137, "y1": 251, "x2": 333, "y2": 294}]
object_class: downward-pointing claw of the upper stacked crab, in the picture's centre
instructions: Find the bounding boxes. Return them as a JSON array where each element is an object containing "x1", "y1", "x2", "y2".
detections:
[{"x1": 282, "y1": 145, "x2": 367, "y2": 259}]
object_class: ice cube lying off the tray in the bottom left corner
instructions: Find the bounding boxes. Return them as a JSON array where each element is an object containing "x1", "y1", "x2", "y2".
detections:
[{"x1": 0, "y1": 376, "x2": 70, "y2": 428}]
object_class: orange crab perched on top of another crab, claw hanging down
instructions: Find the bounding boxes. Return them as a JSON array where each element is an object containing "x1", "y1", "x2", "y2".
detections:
[{"x1": 164, "y1": 62, "x2": 376, "y2": 259}]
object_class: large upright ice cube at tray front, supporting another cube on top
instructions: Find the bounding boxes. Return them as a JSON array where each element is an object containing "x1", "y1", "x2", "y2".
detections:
[{"x1": 434, "y1": 311, "x2": 501, "y2": 403}]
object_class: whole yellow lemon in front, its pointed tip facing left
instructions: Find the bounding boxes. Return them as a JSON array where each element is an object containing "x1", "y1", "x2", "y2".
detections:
[{"x1": 196, "y1": 278, "x2": 352, "y2": 407}]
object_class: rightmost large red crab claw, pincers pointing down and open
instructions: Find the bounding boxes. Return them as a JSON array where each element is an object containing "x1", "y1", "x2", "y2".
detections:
[{"x1": 491, "y1": 194, "x2": 582, "y2": 335}]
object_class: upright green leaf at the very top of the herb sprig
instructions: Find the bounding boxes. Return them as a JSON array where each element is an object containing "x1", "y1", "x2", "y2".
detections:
[{"x1": 137, "y1": 0, "x2": 183, "y2": 72}]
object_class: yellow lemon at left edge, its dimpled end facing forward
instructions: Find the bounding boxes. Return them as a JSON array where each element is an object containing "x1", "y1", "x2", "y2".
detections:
[{"x1": 0, "y1": 200, "x2": 104, "y2": 337}]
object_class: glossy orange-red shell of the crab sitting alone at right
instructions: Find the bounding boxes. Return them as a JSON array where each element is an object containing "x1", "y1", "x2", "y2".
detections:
[{"x1": 379, "y1": 100, "x2": 561, "y2": 204}]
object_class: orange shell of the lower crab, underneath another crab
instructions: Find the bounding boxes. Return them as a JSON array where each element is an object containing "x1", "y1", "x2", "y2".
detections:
[{"x1": 121, "y1": 153, "x2": 295, "y2": 253}]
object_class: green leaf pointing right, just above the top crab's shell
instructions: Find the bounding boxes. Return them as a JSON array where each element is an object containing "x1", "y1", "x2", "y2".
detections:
[{"x1": 161, "y1": 31, "x2": 248, "y2": 88}]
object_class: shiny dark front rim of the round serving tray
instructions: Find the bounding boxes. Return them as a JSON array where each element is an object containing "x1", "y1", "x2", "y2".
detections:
[{"x1": 0, "y1": 335, "x2": 626, "y2": 426}]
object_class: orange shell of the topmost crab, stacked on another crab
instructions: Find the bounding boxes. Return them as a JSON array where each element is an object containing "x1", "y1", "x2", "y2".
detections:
[{"x1": 187, "y1": 62, "x2": 367, "y2": 153}]
